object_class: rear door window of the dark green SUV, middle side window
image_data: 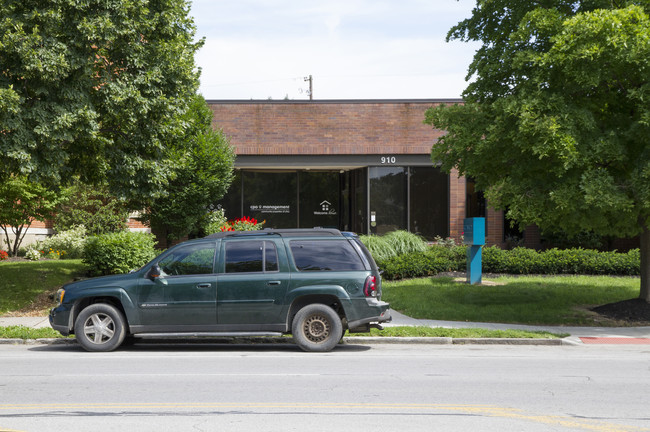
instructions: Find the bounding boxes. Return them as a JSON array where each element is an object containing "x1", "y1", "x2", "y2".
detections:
[{"x1": 225, "y1": 241, "x2": 278, "y2": 273}]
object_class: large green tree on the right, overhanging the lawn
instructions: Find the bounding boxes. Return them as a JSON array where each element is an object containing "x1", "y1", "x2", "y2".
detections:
[{"x1": 425, "y1": 0, "x2": 650, "y2": 302}]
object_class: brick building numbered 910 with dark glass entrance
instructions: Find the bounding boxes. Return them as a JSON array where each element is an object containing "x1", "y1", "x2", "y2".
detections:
[{"x1": 208, "y1": 99, "x2": 504, "y2": 245}]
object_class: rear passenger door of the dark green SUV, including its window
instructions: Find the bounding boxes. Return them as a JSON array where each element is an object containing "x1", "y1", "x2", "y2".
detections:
[{"x1": 217, "y1": 239, "x2": 289, "y2": 330}]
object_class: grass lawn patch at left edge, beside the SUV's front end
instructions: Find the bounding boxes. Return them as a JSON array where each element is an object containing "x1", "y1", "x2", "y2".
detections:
[{"x1": 0, "y1": 259, "x2": 85, "y2": 315}]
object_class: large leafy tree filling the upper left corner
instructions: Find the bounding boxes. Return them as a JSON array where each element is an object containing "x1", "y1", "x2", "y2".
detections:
[{"x1": 0, "y1": 0, "x2": 202, "y2": 199}]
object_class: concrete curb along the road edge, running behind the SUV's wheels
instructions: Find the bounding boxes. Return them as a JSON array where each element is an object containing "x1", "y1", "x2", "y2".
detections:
[{"x1": 0, "y1": 336, "x2": 568, "y2": 346}]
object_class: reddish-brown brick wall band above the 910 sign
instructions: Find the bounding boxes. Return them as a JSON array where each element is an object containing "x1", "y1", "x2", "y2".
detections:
[{"x1": 208, "y1": 100, "x2": 450, "y2": 155}]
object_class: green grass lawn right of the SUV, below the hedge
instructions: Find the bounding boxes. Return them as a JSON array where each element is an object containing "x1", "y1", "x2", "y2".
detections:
[{"x1": 382, "y1": 276, "x2": 640, "y2": 326}]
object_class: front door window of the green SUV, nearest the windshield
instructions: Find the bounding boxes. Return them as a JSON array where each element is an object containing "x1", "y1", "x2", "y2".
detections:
[{"x1": 158, "y1": 243, "x2": 216, "y2": 276}]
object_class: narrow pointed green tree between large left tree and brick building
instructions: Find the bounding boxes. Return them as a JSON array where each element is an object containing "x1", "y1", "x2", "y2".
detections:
[{"x1": 142, "y1": 96, "x2": 235, "y2": 245}]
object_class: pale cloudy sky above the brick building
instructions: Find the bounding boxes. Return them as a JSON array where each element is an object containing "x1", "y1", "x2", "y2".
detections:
[{"x1": 185, "y1": 0, "x2": 478, "y2": 100}]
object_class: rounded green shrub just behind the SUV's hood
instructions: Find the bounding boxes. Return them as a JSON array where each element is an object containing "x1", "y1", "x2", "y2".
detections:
[{"x1": 83, "y1": 231, "x2": 156, "y2": 276}]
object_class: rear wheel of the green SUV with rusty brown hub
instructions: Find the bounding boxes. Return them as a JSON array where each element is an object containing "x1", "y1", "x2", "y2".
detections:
[{"x1": 291, "y1": 303, "x2": 343, "y2": 352}]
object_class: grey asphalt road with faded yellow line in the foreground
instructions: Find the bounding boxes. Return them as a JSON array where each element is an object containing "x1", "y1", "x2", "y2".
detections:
[{"x1": 0, "y1": 345, "x2": 650, "y2": 432}]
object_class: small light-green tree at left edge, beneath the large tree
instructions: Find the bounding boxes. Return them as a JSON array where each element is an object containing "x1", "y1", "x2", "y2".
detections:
[{"x1": 0, "y1": 177, "x2": 59, "y2": 256}]
